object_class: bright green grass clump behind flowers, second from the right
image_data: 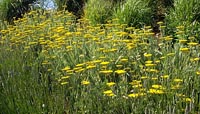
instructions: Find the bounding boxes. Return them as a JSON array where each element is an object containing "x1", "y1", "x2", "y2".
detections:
[{"x1": 113, "y1": 0, "x2": 153, "y2": 27}]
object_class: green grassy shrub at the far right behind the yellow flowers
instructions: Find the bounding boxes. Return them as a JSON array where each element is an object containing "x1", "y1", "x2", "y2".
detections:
[{"x1": 165, "y1": 0, "x2": 200, "y2": 40}]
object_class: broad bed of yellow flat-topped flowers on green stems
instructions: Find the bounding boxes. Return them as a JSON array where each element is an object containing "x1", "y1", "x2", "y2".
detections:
[{"x1": 0, "y1": 10, "x2": 200, "y2": 114}]
